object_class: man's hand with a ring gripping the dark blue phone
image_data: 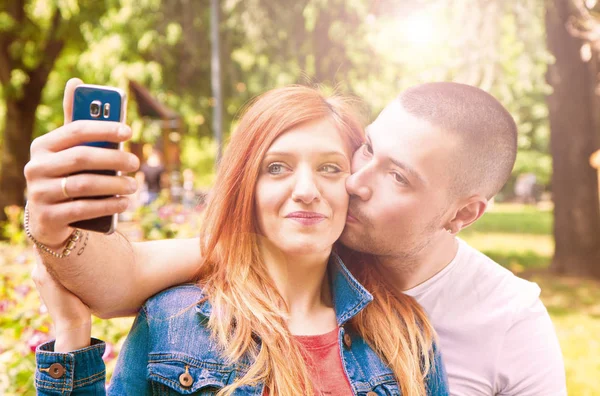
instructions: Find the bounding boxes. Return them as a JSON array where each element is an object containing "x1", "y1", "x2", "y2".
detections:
[{"x1": 24, "y1": 78, "x2": 139, "y2": 250}]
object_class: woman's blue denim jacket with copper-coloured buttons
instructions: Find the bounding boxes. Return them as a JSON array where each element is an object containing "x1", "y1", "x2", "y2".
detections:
[{"x1": 35, "y1": 255, "x2": 449, "y2": 396}]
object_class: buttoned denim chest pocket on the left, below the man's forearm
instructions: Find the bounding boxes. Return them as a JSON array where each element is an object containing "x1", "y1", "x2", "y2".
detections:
[{"x1": 148, "y1": 354, "x2": 233, "y2": 396}]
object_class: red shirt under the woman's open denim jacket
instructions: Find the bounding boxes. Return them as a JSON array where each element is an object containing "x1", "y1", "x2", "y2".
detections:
[{"x1": 264, "y1": 328, "x2": 354, "y2": 396}]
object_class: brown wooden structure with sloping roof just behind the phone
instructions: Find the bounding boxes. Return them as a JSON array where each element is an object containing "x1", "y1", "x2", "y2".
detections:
[{"x1": 129, "y1": 80, "x2": 183, "y2": 172}]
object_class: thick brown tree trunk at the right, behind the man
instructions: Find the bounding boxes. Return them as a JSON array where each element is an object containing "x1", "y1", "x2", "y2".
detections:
[{"x1": 546, "y1": 0, "x2": 600, "y2": 278}]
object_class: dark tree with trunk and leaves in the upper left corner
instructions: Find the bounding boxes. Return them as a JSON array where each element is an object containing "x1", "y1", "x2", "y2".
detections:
[{"x1": 0, "y1": 0, "x2": 105, "y2": 220}]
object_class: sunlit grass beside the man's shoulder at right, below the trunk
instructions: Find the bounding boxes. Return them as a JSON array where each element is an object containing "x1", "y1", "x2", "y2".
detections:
[{"x1": 461, "y1": 204, "x2": 600, "y2": 396}]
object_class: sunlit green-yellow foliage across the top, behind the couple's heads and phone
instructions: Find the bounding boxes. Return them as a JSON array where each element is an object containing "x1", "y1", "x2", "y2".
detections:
[{"x1": 0, "y1": 0, "x2": 550, "y2": 195}]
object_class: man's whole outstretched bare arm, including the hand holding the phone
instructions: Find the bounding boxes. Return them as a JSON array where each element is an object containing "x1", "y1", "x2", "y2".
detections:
[{"x1": 24, "y1": 79, "x2": 200, "y2": 317}]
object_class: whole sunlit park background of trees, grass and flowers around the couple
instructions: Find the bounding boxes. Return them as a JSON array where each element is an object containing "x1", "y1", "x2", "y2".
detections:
[{"x1": 0, "y1": 0, "x2": 600, "y2": 396}]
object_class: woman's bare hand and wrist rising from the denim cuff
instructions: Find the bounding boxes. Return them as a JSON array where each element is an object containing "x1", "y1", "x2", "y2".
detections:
[{"x1": 31, "y1": 253, "x2": 92, "y2": 352}]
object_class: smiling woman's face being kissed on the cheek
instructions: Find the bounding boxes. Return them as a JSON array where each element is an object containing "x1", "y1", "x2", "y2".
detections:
[{"x1": 255, "y1": 120, "x2": 351, "y2": 255}]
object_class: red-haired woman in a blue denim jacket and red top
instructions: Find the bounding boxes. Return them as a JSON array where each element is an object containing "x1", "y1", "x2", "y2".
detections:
[{"x1": 36, "y1": 86, "x2": 448, "y2": 396}]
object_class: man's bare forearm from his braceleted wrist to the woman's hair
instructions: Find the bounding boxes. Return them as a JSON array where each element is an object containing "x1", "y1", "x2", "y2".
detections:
[{"x1": 42, "y1": 232, "x2": 201, "y2": 318}]
